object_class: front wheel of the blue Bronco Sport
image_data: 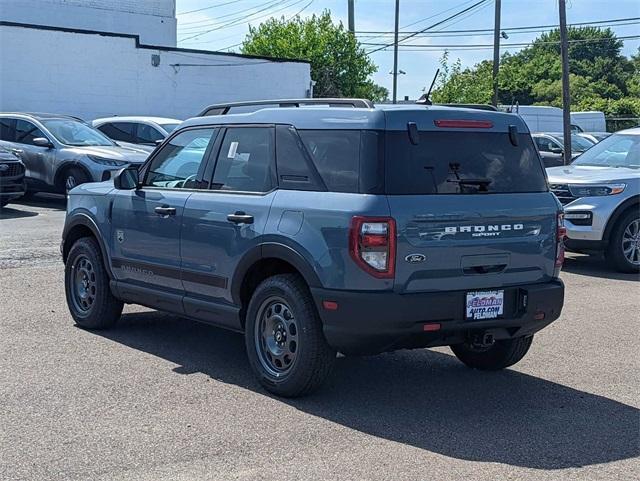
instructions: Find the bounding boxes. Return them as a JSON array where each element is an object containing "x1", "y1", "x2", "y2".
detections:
[{"x1": 64, "y1": 237, "x2": 124, "y2": 329}]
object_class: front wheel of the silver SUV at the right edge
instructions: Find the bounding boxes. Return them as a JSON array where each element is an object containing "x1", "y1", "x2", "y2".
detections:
[{"x1": 605, "y1": 206, "x2": 640, "y2": 272}]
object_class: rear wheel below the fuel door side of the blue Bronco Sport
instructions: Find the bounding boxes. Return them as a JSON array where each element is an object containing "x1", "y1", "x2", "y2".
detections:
[{"x1": 245, "y1": 274, "x2": 336, "y2": 397}]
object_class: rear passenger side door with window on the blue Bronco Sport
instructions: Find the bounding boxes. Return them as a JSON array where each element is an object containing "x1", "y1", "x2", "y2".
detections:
[{"x1": 181, "y1": 126, "x2": 276, "y2": 312}]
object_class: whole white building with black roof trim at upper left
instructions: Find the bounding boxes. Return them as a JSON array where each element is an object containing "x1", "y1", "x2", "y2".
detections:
[{"x1": 0, "y1": 0, "x2": 311, "y2": 120}]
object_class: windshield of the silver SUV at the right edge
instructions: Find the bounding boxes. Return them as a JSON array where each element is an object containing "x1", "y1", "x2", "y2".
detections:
[{"x1": 572, "y1": 134, "x2": 640, "y2": 169}]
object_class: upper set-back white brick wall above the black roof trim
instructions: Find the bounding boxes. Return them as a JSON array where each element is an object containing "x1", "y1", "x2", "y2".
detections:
[{"x1": 0, "y1": 0, "x2": 177, "y2": 47}]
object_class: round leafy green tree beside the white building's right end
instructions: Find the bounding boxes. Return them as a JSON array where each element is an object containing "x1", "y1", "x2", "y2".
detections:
[{"x1": 242, "y1": 10, "x2": 389, "y2": 101}]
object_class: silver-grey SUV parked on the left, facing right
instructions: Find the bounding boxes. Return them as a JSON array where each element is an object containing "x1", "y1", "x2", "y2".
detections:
[{"x1": 0, "y1": 113, "x2": 148, "y2": 193}]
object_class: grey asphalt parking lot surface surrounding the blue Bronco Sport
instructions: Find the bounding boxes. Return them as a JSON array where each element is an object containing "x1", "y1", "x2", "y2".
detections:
[{"x1": 0, "y1": 198, "x2": 640, "y2": 481}]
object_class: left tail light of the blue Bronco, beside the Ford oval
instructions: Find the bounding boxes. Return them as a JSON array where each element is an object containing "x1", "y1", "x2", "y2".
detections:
[{"x1": 349, "y1": 216, "x2": 396, "y2": 279}]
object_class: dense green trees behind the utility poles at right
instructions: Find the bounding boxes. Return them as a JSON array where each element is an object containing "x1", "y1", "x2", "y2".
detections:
[{"x1": 433, "y1": 27, "x2": 640, "y2": 116}]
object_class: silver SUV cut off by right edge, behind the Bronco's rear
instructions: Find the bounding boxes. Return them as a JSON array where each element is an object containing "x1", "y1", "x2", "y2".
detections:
[{"x1": 547, "y1": 128, "x2": 640, "y2": 272}]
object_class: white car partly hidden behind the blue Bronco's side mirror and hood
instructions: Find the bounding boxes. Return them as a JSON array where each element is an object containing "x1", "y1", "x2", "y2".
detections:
[{"x1": 92, "y1": 116, "x2": 182, "y2": 152}]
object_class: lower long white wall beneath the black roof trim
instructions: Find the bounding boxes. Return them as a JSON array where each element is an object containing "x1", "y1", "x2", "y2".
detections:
[{"x1": 0, "y1": 26, "x2": 310, "y2": 120}]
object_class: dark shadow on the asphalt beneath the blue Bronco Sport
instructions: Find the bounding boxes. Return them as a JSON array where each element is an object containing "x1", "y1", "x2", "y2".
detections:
[{"x1": 97, "y1": 311, "x2": 640, "y2": 470}]
